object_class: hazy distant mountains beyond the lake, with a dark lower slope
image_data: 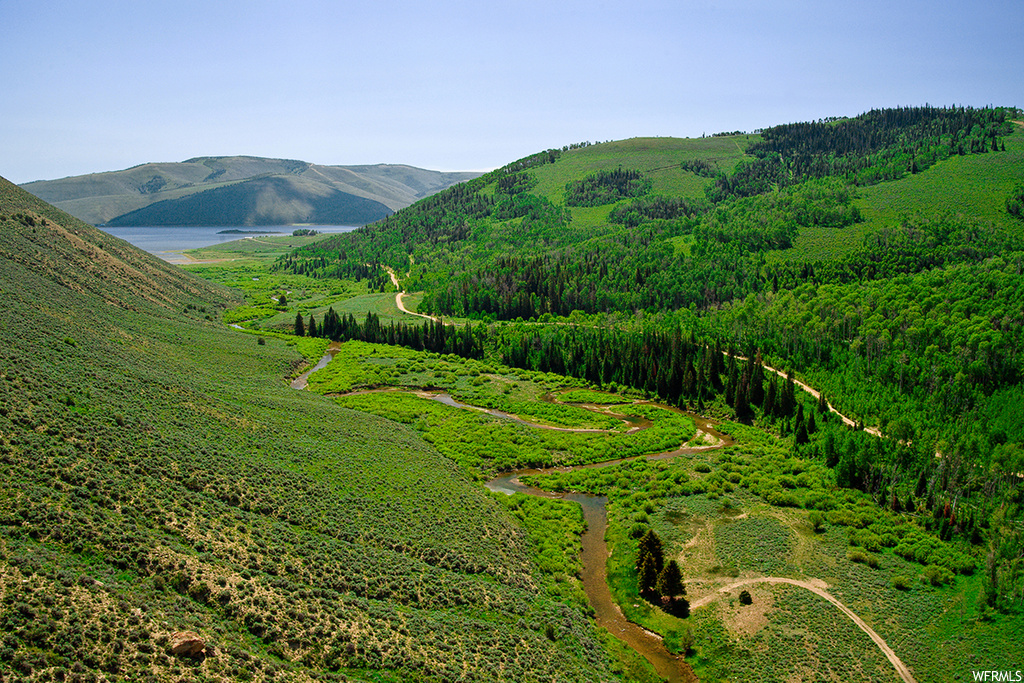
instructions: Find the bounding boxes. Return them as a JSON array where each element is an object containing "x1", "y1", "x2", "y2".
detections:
[{"x1": 22, "y1": 157, "x2": 480, "y2": 226}]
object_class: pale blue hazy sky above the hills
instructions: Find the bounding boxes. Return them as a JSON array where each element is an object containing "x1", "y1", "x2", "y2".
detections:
[{"x1": 0, "y1": 0, "x2": 1024, "y2": 182}]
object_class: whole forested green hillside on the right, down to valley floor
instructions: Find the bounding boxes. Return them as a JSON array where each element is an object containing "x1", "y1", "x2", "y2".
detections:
[{"x1": 279, "y1": 106, "x2": 1024, "y2": 626}]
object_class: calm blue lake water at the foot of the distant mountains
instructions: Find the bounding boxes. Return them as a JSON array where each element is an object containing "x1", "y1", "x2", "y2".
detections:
[{"x1": 100, "y1": 225, "x2": 357, "y2": 261}]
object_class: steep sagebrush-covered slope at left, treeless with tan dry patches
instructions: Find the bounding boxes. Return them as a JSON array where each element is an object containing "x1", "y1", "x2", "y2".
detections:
[{"x1": 0, "y1": 180, "x2": 611, "y2": 681}]
